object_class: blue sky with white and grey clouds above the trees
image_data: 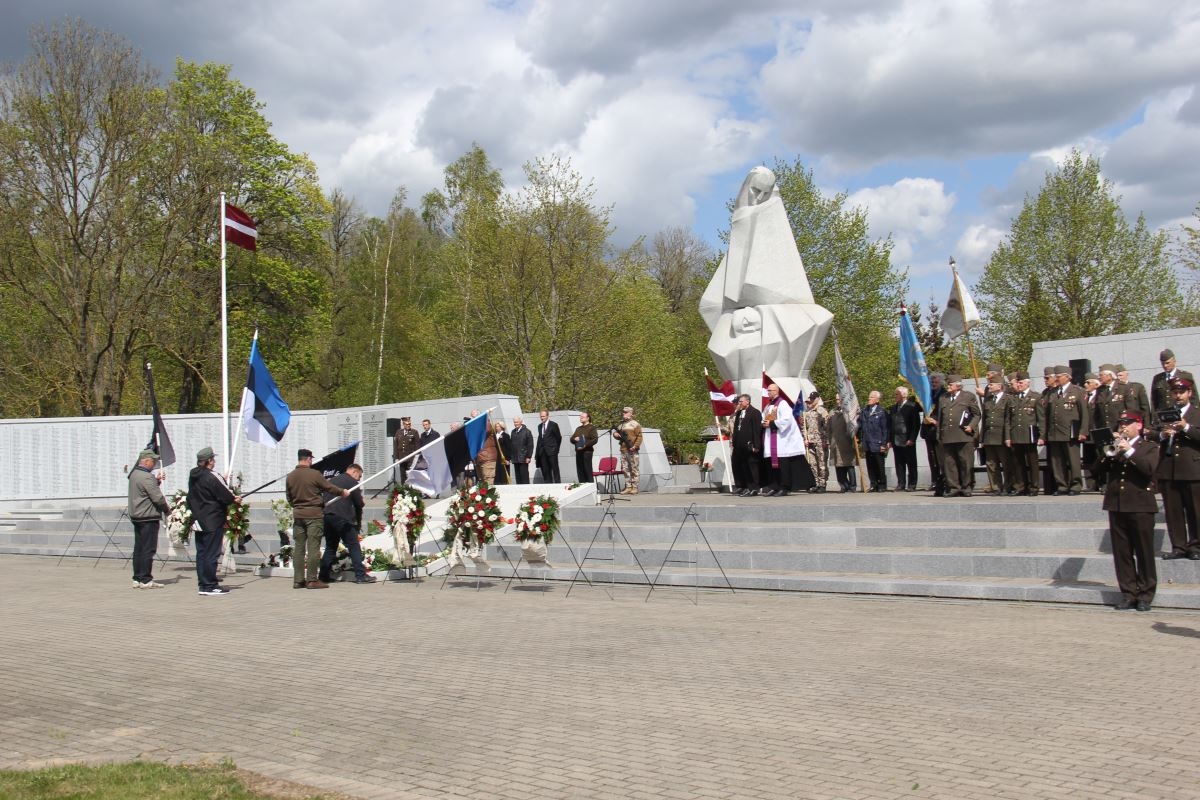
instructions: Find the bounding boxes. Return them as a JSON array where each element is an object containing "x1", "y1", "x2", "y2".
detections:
[{"x1": 0, "y1": 0, "x2": 1200, "y2": 306}]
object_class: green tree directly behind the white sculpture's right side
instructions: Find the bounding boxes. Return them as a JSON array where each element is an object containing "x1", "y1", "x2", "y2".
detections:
[{"x1": 772, "y1": 158, "x2": 908, "y2": 398}]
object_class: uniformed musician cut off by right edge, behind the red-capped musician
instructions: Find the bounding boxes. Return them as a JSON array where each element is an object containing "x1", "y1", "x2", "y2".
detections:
[{"x1": 1156, "y1": 378, "x2": 1200, "y2": 561}]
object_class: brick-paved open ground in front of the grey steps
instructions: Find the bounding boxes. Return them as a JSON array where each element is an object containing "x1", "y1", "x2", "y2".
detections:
[{"x1": 0, "y1": 557, "x2": 1200, "y2": 800}]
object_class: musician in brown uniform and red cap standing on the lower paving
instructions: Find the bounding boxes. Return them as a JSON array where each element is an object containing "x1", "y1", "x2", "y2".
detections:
[{"x1": 1104, "y1": 411, "x2": 1159, "y2": 612}]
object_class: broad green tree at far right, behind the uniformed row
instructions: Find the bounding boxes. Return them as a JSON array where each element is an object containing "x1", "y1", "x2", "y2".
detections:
[{"x1": 973, "y1": 150, "x2": 1183, "y2": 365}]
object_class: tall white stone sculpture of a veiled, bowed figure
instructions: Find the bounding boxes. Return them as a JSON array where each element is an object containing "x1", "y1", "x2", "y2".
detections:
[{"x1": 700, "y1": 167, "x2": 833, "y2": 404}]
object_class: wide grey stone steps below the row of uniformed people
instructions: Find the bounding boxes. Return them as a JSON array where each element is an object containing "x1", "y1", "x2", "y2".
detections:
[{"x1": 7, "y1": 493, "x2": 1200, "y2": 608}]
